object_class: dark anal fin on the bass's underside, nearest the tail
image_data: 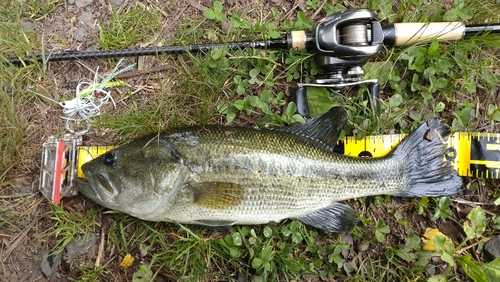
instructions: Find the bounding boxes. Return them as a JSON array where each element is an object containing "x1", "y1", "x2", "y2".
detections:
[{"x1": 296, "y1": 203, "x2": 359, "y2": 233}]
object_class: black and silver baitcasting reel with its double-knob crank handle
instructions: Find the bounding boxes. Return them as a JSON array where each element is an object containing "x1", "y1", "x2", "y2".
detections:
[{"x1": 295, "y1": 9, "x2": 384, "y2": 116}]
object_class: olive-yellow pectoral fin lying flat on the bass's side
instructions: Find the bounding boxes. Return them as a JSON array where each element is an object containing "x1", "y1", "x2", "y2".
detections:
[{"x1": 188, "y1": 181, "x2": 245, "y2": 210}]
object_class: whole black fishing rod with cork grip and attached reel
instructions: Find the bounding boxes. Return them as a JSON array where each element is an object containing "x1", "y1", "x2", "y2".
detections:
[{"x1": 7, "y1": 9, "x2": 500, "y2": 113}]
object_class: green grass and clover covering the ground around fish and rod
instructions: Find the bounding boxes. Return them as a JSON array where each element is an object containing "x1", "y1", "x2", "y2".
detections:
[{"x1": 0, "y1": 0, "x2": 500, "y2": 281}]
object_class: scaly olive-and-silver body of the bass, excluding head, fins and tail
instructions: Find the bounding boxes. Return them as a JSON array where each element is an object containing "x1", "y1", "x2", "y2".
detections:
[{"x1": 124, "y1": 126, "x2": 404, "y2": 224}]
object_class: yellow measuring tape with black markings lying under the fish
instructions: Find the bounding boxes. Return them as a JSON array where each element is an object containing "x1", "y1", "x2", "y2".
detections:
[{"x1": 78, "y1": 132, "x2": 500, "y2": 179}]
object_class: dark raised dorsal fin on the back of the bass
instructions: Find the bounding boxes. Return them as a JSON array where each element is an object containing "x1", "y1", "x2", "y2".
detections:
[{"x1": 278, "y1": 107, "x2": 347, "y2": 146}]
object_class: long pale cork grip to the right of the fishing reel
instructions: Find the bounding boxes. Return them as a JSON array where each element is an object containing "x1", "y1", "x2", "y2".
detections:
[{"x1": 393, "y1": 22, "x2": 465, "y2": 46}]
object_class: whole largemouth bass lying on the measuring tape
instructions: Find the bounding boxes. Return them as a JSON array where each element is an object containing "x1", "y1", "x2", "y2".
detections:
[{"x1": 77, "y1": 107, "x2": 462, "y2": 232}]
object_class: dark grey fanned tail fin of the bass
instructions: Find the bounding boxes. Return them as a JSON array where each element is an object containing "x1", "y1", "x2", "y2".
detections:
[{"x1": 391, "y1": 119, "x2": 462, "y2": 197}]
